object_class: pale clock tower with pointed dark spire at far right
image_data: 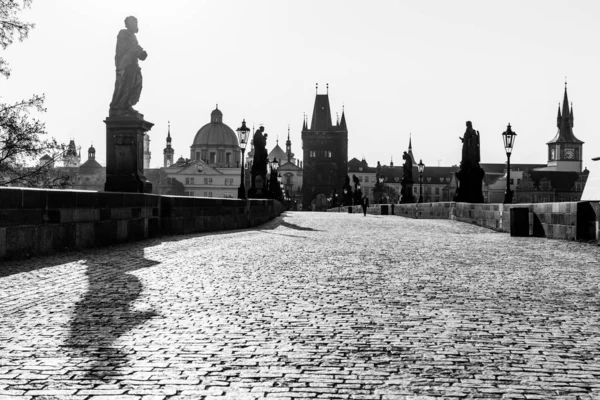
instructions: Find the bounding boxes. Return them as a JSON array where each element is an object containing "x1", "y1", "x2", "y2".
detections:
[{"x1": 545, "y1": 83, "x2": 583, "y2": 172}]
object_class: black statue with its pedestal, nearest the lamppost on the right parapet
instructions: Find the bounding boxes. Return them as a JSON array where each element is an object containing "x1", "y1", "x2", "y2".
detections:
[{"x1": 454, "y1": 121, "x2": 485, "y2": 203}]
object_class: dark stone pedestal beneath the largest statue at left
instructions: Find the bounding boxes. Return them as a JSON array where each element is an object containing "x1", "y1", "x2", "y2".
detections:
[{"x1": 104, "y1": 117, "x2": 154, "y2": 193}]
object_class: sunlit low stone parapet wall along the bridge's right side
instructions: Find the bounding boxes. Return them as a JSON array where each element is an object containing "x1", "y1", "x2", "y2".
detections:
[{"x1": 329, "y1": 201, "x2": 600, "y2": 243}]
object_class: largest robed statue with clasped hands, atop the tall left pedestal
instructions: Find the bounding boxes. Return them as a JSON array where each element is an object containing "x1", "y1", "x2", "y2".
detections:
[{"x1": 109, "y1": 16, "x2": 148, "y2": 118}]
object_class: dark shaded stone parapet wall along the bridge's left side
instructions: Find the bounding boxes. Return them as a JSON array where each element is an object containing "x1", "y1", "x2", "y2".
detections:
[{"x1": 0, "y1": 188, "x2": 284, "y2": 260}]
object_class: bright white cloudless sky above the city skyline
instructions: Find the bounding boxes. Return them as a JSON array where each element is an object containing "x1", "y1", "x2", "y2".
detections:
[{"x1": 0, "y1": 0, "x2": 600, "y2": 167}]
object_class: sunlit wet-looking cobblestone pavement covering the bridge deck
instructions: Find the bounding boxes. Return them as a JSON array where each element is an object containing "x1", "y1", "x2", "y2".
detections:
[{"x1": 0, "y1": 213, "x2": 600, "y2": 400}]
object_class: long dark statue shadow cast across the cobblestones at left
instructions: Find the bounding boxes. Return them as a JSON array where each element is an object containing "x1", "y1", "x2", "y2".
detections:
[{"x1": 64, "y1": 243, "x2": 158, "y2": 380}]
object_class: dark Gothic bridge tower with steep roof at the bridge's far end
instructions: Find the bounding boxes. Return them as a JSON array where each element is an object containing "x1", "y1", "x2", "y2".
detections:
[{"x1": 302, "y1": 85, "x2": 348, "y2": 210}]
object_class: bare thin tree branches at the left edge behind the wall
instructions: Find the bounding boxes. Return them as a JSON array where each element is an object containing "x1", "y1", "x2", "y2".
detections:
[{"x1": 0, "y1": 0, "x2": 69, "y2": 188}]
